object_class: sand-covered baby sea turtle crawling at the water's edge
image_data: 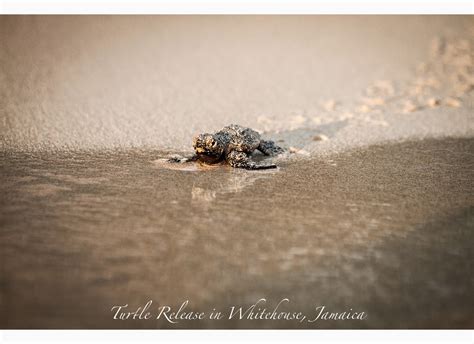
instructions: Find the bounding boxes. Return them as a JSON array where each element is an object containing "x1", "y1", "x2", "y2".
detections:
[{"x1": 178, "y1": 124, "x2": 284, "y2": 170}]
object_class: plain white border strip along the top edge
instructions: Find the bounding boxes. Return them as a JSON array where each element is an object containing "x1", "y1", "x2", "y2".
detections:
[{"x1": 0, "y1": 0, "x2": 474, "y2": 14}]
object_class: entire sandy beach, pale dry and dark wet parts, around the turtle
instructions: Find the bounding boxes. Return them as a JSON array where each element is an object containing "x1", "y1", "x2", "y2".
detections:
[{"x1": 0, "y1": 16, "x2": 474, "y2": 328}]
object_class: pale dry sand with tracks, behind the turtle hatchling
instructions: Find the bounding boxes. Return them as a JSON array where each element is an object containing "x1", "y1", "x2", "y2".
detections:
[{"x1": 0, "y1": 16, "x2": 474, "y2": 152}]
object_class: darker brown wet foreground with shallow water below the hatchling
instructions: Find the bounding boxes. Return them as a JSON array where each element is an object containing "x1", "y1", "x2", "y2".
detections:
[{"x1": 0, "y1": 139, "x2": 474, "y2": 328}]
